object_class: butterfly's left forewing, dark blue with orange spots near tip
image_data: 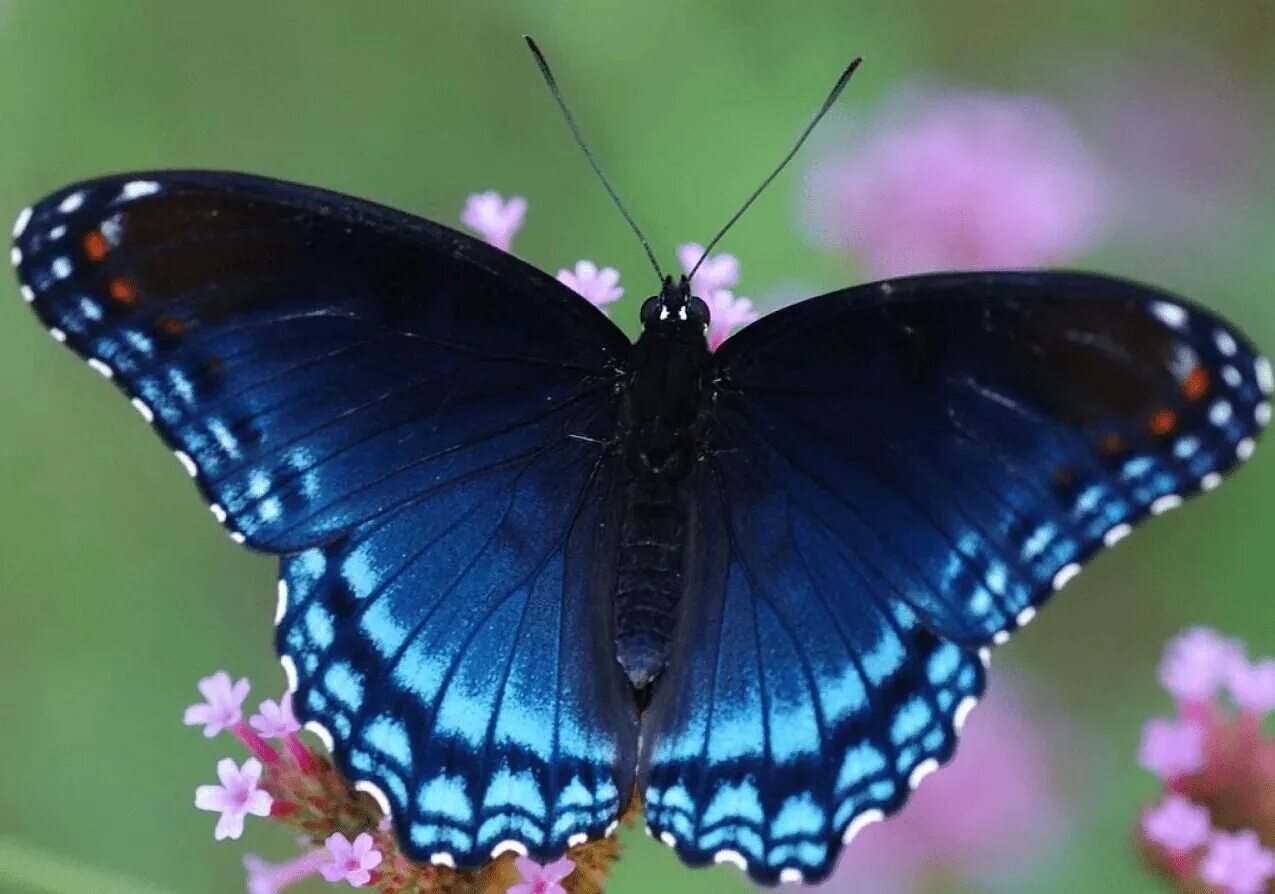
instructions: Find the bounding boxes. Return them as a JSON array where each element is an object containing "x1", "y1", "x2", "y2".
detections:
[{"x1": 13, "y1": 172, "x2": 629, "y2": 552}]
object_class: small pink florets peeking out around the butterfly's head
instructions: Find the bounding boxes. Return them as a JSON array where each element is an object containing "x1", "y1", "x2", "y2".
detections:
[{"x1": 460, "y1": 191, "x2": 757, "y2": 351}]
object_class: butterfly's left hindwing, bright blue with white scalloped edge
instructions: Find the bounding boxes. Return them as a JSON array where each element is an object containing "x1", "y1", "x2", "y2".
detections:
[{"x1": 278, "y1": 392, "x2": 636, "y2": 867}]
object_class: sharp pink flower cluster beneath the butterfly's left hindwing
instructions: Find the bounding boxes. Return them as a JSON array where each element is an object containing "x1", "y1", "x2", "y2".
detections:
[{"x1": 184, "y1": 671, "x2": 591, "y2": 894}]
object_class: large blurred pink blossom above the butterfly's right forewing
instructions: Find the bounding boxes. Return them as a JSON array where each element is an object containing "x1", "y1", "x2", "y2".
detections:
[{"x1": 805, "y1": 92, "x2": 1109, "y2": 277}]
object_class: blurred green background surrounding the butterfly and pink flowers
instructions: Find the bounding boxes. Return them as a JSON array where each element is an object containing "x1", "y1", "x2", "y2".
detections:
[{"x1": 0, "y1": 0, "x2": 1275, "y2": 894}]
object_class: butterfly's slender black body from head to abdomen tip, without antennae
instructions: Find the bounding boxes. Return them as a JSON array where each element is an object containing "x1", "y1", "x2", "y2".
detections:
[{"x1": 616, "y1": 282, "x2": 710, "y2": 689}]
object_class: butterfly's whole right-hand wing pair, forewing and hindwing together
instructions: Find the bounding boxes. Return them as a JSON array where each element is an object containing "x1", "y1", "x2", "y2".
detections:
[{"x1": 639, "y1": 273, "x2": 1272, "y2": 883}]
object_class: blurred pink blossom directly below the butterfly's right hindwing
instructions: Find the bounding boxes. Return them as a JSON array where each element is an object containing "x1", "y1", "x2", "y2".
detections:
[{"x1": 805, "y1": 682, "x2": 1066, "y2": 894}]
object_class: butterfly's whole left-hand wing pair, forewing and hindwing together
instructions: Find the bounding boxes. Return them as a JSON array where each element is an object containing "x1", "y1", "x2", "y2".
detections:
[{"x1": 13, "y1": 172, "x2": 636, "y2": 866}]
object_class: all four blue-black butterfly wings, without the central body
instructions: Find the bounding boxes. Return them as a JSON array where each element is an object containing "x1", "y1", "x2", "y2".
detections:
[{"x1": 13, "y1": 172, "x2": 1272, "y2": 884}]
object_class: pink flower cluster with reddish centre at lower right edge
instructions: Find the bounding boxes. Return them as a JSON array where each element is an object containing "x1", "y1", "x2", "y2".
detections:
[{"x1": 1139, "y1": 627, "x2": 1275, "y2": 894}]
